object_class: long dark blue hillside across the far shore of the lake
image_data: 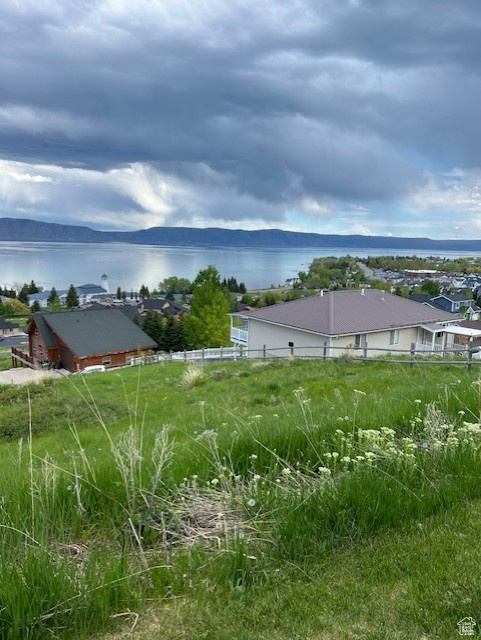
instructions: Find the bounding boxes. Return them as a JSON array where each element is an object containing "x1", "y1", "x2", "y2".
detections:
[{"x1": 0, "y1": 218, "x2": 481, "y2": 253}]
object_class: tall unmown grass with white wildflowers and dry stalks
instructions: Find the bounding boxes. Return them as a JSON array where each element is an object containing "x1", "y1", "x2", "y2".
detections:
[{"x1": 0, "y1": 361, "x2": 481, "y2": 640}]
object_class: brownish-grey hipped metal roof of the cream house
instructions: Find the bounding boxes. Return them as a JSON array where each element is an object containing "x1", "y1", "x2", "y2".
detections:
[{"x1": 236, "y1": 289, "x2": 458, "y2": 336}]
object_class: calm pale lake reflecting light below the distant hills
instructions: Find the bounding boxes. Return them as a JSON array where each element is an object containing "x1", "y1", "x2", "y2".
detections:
[{"x1": 0, "y1": 242, "x2": 472, "y2": 291}]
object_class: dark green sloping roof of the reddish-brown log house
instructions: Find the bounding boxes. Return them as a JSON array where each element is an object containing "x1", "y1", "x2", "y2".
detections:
[{"x1": 35, "y1": 309, "x2": 157, "y2": 358}]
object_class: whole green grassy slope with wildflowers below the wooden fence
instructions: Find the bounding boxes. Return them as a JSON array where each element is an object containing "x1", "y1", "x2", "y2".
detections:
[{"x1": 0, "y1": 360, "x2": 481, "y2": 640}]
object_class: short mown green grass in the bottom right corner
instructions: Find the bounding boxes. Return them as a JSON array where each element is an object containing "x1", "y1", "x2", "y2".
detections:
[{"x1": 126, "y1": 501, "x2": 481, "y2": 640}]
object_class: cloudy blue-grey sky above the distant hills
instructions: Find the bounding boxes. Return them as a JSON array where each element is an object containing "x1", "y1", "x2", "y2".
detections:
[{"x1": 0, "y1": 0, "x2": 481, "y2": 239}]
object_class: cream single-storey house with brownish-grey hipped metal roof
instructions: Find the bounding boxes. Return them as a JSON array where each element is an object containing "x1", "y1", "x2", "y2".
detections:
[{"x1": 231, "y1": 289, "x2": 460, "y2": 357}]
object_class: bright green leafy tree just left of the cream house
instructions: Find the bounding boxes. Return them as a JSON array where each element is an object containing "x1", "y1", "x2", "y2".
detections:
[{"x1": 184, "y1": 265, "x2": 230, "y2": 349}]
